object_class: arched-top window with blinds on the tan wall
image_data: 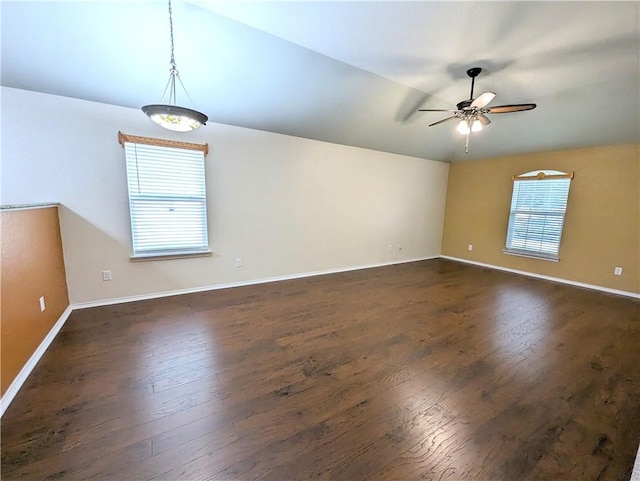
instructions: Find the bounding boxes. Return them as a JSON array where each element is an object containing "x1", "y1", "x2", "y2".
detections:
[{"x1": 503, "y1": 170, "x2": 573, "y2": 261}]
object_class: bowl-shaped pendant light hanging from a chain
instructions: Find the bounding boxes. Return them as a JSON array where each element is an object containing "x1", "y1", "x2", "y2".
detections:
[{"x1": 142, "y1": 0, "x2": 209, "y2": 132}]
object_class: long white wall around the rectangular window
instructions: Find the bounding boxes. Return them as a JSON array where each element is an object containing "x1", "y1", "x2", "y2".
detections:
[{"x1": 0, "y1": 87, "x2": 448, "y2": 303}]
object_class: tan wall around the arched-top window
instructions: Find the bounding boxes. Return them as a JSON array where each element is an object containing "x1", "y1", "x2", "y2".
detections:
[{"x1": 442, "y1": 144, "x2": 640, "y2": 293}]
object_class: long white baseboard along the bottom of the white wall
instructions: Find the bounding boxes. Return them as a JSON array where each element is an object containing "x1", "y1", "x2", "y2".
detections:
[{"x1": 71, "y1": 256, "x2": 440, "y2": 310}]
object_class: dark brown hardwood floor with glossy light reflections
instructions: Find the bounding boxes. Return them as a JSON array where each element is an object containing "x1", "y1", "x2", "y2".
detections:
[{"x1": 1, "y1": 259, "x2": 640, "y2": 481}]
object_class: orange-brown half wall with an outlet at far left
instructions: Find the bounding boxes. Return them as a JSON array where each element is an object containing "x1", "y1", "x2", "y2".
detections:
[{"x1": 0, "y1": 207, "x2": 69, "y2": 395}]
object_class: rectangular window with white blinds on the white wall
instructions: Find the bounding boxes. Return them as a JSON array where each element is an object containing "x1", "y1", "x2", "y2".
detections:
[{"x1": 118, "y1": 133, "x2": 209, "y2": 258}]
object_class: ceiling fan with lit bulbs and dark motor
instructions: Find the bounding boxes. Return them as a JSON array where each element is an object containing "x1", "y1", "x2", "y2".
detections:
[{"x1": 419, "y1": 67, "x2": 536, "y2": 153}]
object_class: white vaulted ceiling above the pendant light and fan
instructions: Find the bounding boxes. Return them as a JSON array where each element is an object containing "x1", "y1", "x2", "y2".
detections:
[{"x1": 1, "y1": 0, "x2": 640, "y2": 161}]
